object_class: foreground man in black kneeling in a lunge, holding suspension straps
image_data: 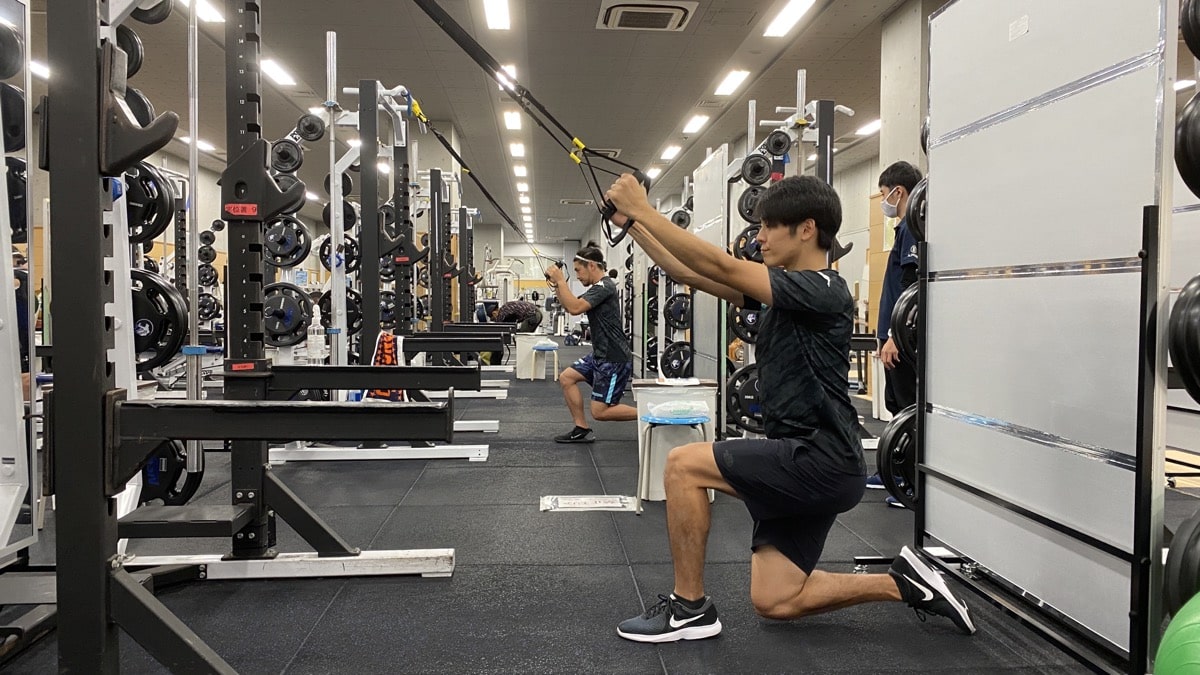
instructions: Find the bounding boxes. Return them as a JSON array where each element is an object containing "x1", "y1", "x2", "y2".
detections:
[{"x1": 607, "y1": 174, "x2": 974, "y2": 643}]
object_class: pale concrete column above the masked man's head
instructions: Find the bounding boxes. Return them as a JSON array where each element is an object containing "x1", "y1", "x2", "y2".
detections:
[{"x1": 880, "y1": 0, "x2": 946, "y2": 172}]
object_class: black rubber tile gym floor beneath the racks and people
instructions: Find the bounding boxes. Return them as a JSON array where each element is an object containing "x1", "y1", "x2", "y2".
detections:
[{"x1": 11, "y1": 347, "x2": 1200, "y2": 674}]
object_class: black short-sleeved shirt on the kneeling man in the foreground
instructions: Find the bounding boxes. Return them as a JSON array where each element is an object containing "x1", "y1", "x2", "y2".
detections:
[{"x1": 746, "y1": 268, "x2": 863, "y2": 472}]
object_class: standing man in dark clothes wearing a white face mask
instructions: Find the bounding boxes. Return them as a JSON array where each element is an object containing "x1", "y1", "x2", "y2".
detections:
[{"x1": 866, "y1": 162, "x2": 920, "y2": 508}]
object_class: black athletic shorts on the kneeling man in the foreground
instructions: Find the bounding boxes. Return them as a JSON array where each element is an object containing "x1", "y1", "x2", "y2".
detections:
[{"x1": 713, "y1": 438, "x2": 866, "y2": 574}]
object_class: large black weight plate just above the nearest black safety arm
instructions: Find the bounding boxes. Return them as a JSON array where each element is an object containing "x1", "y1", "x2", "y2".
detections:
[{"x1": 131, "y1": 269, "x2": 187, "y2": 372}]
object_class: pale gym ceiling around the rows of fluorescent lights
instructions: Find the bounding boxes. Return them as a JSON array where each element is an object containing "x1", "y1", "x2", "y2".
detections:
[{"x1": 31, "y1": 0, "x2": 901, "y2": 241}]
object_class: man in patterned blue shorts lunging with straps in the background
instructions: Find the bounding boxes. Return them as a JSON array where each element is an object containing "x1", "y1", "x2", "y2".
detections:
[{"x1": 546, "y1": 241, "x2": 637, "y2": 443}]
